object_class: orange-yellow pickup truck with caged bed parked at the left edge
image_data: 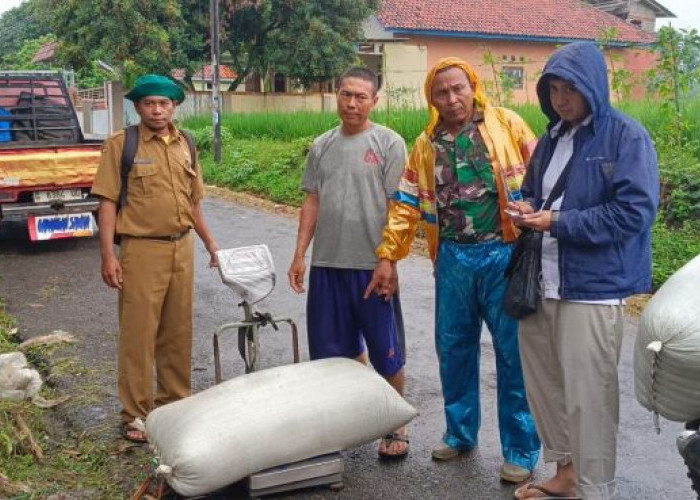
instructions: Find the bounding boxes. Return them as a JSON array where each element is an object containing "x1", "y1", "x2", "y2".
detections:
[{"x1": 0, "y1": 71, "x2": 102, "y2": 241}]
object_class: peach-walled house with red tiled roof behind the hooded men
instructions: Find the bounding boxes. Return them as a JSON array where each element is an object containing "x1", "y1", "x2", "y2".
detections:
[{"x1": 359, "y1": 0, "x2": 675, "y2": 106}]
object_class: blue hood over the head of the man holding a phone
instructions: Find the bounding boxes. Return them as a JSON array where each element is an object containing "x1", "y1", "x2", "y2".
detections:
[{"x1": 537, "y1": 42, "x2": 610, "y2": 126}]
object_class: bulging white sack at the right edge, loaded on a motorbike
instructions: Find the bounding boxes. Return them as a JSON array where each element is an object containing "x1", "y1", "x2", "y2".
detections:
[{"x1": 634, "y1": 256, "x2": 700, "y2": 422}]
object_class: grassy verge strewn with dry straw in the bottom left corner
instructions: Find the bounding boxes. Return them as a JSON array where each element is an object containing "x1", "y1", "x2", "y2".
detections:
[{"x1": 0, "y1": 302, "x2": 150, "y2": 500}]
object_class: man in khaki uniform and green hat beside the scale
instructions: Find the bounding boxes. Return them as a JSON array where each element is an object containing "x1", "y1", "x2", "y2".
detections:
[{"x1": 92, "y1": 75, "x2": 218, "y2": 442}]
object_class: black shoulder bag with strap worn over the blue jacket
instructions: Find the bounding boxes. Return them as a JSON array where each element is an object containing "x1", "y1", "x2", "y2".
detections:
[{"x1": 503, "y1": 155, "x2": 573, "y2": 319}]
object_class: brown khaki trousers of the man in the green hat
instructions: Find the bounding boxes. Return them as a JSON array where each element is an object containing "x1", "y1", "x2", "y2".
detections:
[{"x1": 118, "y1": 234, "x2": 194, "y2": 422}]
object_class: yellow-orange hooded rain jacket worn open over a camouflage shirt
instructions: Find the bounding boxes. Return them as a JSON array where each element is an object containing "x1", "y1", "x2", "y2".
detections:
[{"x1": 376, "y1": 57, "x2": 537, "y2": 261}]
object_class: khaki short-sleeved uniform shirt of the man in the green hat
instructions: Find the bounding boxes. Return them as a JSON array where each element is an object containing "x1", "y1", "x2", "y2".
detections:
[{"x1": 92, "y1": 125, "x2": 204, "y2": 236}]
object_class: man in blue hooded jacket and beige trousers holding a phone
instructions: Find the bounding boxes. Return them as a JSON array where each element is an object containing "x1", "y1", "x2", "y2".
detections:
[{"x1": 510, "y1": 42, "x2": 659, "y2": 500}]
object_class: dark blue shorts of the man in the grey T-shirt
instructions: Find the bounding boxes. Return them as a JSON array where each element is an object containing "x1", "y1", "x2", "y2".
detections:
[{"x1": 306, "y1": 266, "x2": 406, "y2": 377}]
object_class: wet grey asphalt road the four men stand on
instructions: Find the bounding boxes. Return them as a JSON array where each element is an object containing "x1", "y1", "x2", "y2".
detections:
[{"x1": 0, "y1": 194, "x2": 694, "y2": 500}]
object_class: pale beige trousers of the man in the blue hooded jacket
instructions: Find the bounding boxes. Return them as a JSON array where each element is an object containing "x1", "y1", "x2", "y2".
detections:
[{"x1": 519, "y1": 299, "x2": 624, "y2": 500}]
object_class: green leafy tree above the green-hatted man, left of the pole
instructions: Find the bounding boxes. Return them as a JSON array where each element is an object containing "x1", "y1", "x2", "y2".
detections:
[{"x1": 49, "y1": 0, "x2": 191, "y2": 85}]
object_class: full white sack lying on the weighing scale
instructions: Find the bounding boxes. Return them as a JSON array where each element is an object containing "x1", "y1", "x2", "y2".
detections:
[{"x1": 146, "y1": 358, "x2": 416, "y2": 496}]
